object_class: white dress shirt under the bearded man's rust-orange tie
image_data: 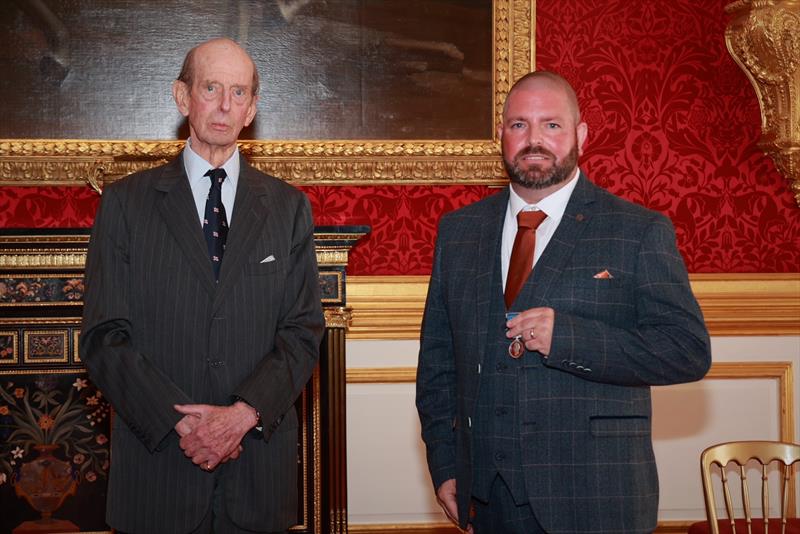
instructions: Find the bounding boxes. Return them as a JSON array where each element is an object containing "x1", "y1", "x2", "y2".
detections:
[{"x1": 500, "y1": 168, "x2": 580, "y2": 289}]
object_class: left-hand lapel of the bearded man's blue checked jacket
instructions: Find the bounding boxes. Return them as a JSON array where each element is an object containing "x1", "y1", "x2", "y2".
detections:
[{"x1": 475, "y1": 191, "x2": 508, "y2": 361}]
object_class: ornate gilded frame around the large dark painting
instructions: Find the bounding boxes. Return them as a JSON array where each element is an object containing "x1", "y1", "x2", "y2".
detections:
[{"x1": 0, "y1": 0, "x2": 536, "y2": 191}]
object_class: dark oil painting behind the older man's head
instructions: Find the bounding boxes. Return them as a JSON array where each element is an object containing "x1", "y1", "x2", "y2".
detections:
[{"x1": 0, "y1": 0, "x2": 493, "y2": 140}]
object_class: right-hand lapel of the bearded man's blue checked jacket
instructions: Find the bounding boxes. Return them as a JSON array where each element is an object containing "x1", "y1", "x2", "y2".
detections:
[{"x1": 528, "y1": 173, "x2": 595, "y2": 306}]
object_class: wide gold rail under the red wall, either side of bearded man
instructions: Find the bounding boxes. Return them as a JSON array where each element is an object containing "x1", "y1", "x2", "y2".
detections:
[{"x1": 347, "y1": 273, "x2": 800, "y2": 339}]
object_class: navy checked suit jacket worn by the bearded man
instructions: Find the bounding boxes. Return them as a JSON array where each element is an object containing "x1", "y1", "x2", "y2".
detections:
[{"x1": 417, "y1": 175, "x2": 711, "y2": 534}]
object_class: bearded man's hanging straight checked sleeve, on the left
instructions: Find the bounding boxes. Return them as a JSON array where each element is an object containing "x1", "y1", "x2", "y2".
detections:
[{"x1": 416, "y1": 226, "x2": 456, "y2": 489}]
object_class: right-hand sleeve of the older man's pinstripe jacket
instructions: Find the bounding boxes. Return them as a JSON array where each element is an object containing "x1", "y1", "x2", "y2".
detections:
[{"x1": 233, "y1": 195, "x2": 325, "y2": 440}]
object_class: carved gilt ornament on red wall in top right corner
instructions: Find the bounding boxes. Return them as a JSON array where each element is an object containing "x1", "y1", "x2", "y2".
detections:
[{"x1": 725, "y1": 0, "x2": 800, "y2": 206}]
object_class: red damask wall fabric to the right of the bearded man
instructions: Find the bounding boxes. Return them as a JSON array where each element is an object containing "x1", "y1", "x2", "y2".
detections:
[{"x1": 536, "y1": 0, "x2": 800, "y2": 272}]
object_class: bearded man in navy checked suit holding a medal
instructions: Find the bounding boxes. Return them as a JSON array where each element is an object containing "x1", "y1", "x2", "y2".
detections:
[{"x1": 417, "y1": 72, "x2": 711, "y2": 534}]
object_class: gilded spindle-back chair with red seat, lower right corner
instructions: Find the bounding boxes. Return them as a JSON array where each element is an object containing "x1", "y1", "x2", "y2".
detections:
[{"x1": 688, "y1": 441, "x2": 800, "y2": 534}]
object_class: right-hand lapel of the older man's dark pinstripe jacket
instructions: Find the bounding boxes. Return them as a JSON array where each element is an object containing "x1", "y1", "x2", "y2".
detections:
[{"x1": 214, "y1": 162, "x2": 269, "y2": 308}]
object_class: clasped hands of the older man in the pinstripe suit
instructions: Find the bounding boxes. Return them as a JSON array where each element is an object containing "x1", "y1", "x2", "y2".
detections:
[{"x1": 175, "y1": 401, "x2": 258, "y2": 471}]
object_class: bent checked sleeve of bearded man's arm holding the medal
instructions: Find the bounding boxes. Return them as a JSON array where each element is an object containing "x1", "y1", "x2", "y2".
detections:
[{"x1": 545, "y1": 216, "x2": 711, "y2": 386}]
